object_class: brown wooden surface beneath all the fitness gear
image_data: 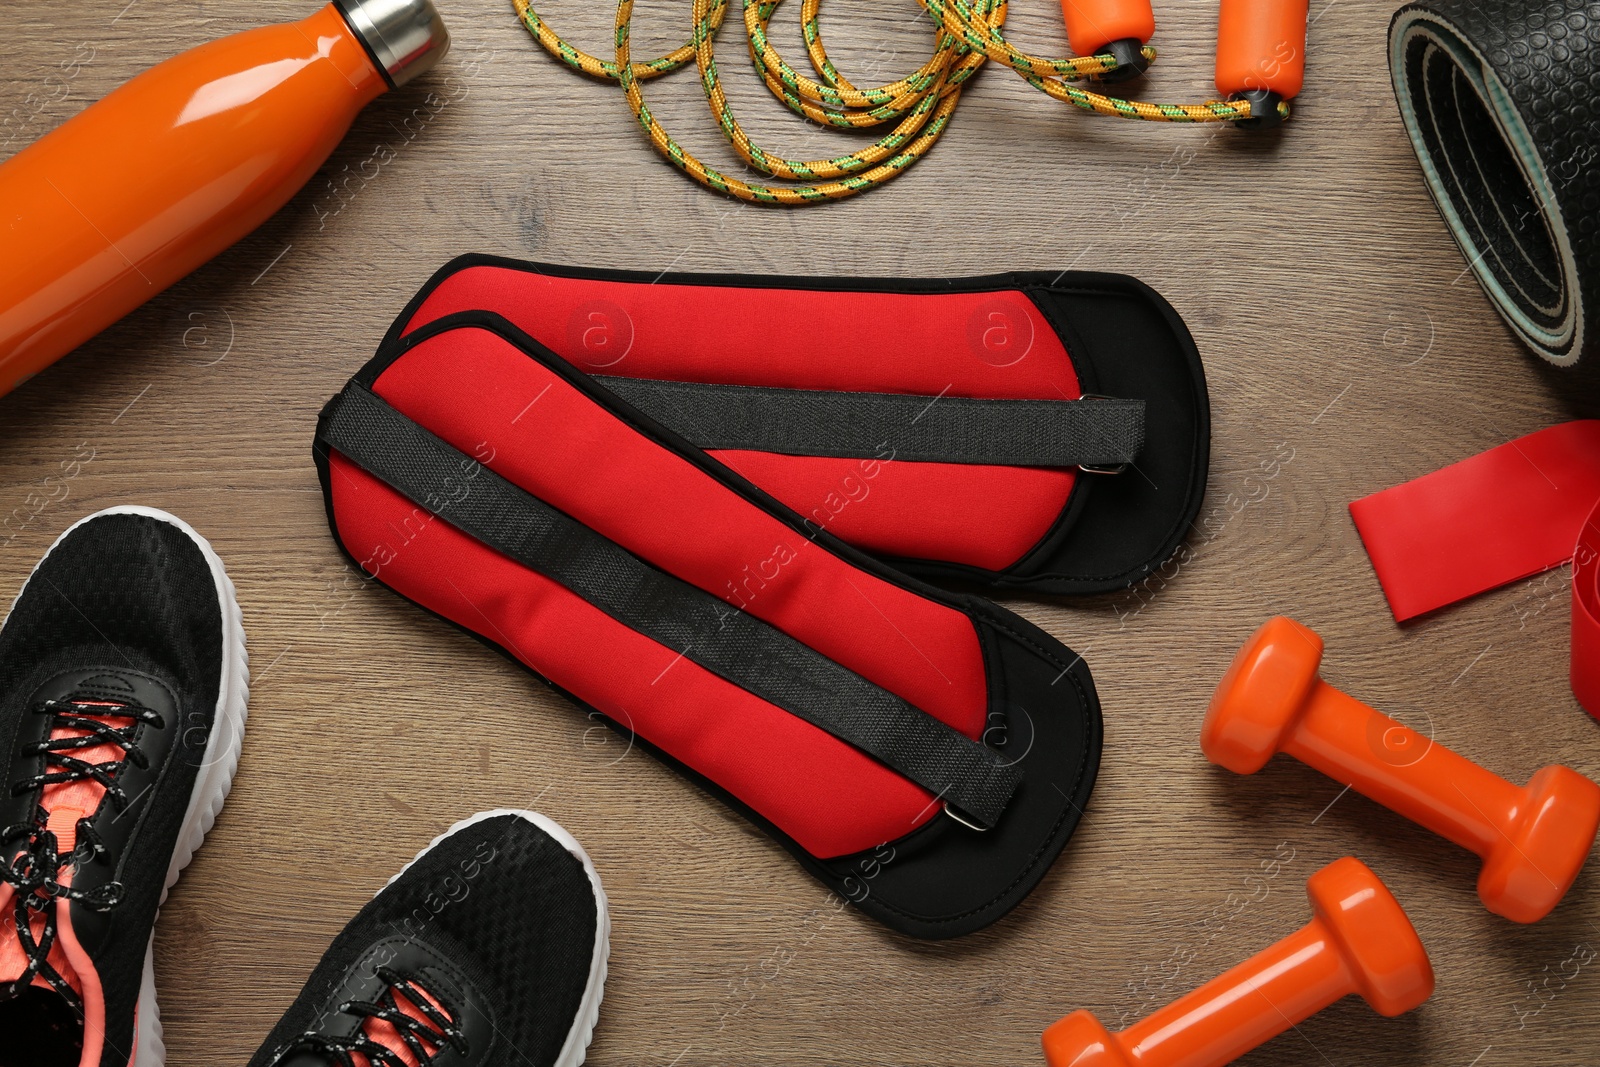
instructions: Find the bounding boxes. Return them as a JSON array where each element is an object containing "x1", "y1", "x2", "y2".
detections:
[{"x1": 0, "y1": 0, "x2": 1600, "y2": 1067}]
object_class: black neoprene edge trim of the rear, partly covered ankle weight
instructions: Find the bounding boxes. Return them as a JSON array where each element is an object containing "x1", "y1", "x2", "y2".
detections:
[{"x1": 368, "y1": 253, "x2": 1211, "y2": 595}]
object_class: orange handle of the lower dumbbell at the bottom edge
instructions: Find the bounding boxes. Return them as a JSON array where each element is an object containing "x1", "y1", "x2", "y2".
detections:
[{"x1": 1115, "y1": 918, "x2": 1357, "y2": 1067}]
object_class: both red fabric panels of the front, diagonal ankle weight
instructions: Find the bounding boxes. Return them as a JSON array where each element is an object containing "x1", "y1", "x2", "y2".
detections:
[{"x1": 331, "y1": 321, "x2": 987, "y2": 856}]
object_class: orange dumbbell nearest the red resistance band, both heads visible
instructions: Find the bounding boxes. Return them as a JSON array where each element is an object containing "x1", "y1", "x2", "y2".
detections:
[{"x1": 1200, "y1": 617, "x2": 1600, "y2": 923}]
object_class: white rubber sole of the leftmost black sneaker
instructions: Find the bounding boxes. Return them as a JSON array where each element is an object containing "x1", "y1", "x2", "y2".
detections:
[{"x1": 19, "y1": 504, "x2": 250, "y2": 1067}]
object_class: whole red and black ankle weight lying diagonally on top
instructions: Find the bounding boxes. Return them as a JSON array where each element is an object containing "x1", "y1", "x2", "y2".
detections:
[{"x1": 315, "y1": 312, "x2": 1101, "y2": 937}]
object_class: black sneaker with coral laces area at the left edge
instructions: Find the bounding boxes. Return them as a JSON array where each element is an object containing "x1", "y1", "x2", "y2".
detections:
[{"x1": 0, "y1": 507, "x2": 248, "y2": 1067}]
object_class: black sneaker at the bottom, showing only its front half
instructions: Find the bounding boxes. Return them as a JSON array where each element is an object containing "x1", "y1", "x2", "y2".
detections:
[{"x1": 250, "y1": 811, "x2": 611, "y2": 1067}]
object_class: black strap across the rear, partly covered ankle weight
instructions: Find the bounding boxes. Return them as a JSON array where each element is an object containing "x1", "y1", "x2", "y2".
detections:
[{"x1": 598, "y1": 376, "x2": 1144, "y2": 467}]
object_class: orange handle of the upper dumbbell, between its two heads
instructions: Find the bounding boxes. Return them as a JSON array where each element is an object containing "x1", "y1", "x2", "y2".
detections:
[{"x1": 1282, "y1": 680, "x2": 1523, "y2": 857}]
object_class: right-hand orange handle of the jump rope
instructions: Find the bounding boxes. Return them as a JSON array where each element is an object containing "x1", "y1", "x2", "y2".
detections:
[{"x1": 1216, "y1": 0, "x2": 1309, "y2": 103}]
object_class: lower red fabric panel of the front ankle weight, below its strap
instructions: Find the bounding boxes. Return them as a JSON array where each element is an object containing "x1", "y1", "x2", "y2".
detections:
[{"x1": 328, "y1": 453, "x2": 939, "y2": 857}]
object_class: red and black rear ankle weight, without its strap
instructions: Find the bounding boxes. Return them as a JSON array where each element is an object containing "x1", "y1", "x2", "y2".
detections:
[{"x1": 389, "y1": 256, "x2": 1210, "y2": 593}]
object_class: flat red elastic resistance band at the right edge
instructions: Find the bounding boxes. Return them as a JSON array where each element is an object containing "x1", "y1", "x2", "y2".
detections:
[{"x1": 1350, "y1": 419, "x2": 1600, "y2": 717}]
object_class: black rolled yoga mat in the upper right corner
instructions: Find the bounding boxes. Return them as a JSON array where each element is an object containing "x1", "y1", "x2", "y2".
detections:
[{"x1": 1389, "y1": 0, "x2": 1600, "y2": 366}]
